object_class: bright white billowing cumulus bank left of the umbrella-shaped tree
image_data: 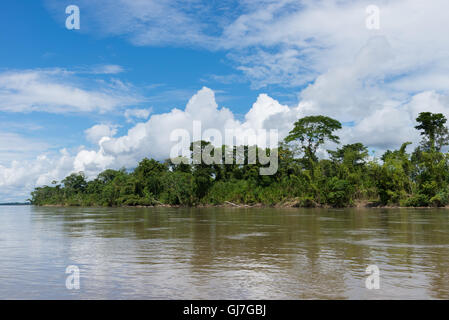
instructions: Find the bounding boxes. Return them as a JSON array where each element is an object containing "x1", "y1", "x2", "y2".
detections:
[{"x1": 79, "y1": 87, "x2": 289, "y2": 169}]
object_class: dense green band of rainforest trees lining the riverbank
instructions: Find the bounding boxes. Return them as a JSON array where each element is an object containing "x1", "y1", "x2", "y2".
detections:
[{"x1": 29, "y1": 112, "x2": 449, "y2": 208}]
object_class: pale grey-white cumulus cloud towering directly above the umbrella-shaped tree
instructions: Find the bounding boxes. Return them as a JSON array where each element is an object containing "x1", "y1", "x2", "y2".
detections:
[{"x1": 299, "y1": 36, "x2": 396, "y2": 122}]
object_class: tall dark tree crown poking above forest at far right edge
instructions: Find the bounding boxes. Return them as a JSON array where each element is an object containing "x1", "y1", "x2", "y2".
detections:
[{"x1": 415, "y1": 112, "x2": 449, "y2": 151}]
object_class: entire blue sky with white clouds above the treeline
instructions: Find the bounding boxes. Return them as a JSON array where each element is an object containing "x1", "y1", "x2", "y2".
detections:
[{"x1": 0, "y1": 0, "x2": 449, "y2": 202}]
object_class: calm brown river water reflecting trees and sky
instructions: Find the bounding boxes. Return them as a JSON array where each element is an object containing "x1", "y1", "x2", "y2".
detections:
[{"x1": 0, "y1": 207, "x2": 449, "y2": 299}]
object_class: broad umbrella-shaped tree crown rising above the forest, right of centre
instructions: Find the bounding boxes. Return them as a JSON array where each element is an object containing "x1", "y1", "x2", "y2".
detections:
[{"x1": 285, "y1": 116, "x2": 341, "y2": 162}]
